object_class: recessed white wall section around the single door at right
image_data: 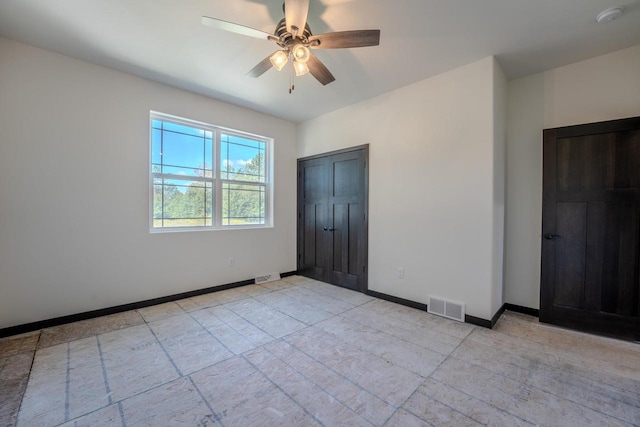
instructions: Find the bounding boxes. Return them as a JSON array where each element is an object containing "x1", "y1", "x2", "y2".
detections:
[{"x1": 505, "y1": 46, "x2": 640, "y2": 308}]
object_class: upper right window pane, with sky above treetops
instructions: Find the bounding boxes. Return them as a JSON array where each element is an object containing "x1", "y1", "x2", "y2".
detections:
[{"x1": 220, "y1": 134, "x2": 266, "y2": 182}]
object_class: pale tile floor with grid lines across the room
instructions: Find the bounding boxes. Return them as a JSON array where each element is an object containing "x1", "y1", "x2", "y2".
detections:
[{"x1": 0, "y1": 276, "x2": 640, "y2": 427}]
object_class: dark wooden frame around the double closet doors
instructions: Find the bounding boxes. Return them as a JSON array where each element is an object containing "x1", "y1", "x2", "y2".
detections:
[{"x1": 296, "y1": 144, "x2": 369, "y2": 293}]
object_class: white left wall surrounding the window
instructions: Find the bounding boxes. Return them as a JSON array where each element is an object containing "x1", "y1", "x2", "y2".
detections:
[{"x1": 0, "y1": 39, "x2": 296, "y2": 328}]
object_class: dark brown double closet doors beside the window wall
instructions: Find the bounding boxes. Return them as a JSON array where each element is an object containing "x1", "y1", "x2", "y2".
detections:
[{"x1": 298, "y1": 147, "x2": 368, "y2": 292}]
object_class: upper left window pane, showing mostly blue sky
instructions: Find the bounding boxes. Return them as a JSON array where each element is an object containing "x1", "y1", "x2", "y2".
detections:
[{"x1": 151, "y1": 120, "x2": 213, "y2": 177}]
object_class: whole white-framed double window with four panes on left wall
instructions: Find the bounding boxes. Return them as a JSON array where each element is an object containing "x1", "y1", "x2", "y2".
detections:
[{"x1": 151, "y1": 112, "x2": 272, "y2": 231}]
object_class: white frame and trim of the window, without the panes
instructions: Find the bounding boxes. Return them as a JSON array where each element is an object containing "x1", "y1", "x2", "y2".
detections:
[{"x1": 147, "y1": 110, "x2": 274, "y2": 233}]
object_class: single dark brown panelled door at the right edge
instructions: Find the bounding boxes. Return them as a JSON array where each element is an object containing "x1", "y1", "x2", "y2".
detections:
[{"x1": 540, "y1": 117, "x2": 640, "y2": 340}]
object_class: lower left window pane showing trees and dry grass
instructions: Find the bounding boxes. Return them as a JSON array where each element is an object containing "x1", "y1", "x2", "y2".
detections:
[{"x1": 153, "y1": 178, "x2": 213, "y2": 227}]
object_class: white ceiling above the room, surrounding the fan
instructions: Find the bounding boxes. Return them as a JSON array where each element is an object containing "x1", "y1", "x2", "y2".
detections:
[{"x1": 0, "y1": 0, "x2": 640, "y2": 122}]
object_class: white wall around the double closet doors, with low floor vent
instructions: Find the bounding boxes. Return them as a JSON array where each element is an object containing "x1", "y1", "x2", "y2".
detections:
[{"x1": 298, "y1": 58, "x2": 506, "y2": 319}]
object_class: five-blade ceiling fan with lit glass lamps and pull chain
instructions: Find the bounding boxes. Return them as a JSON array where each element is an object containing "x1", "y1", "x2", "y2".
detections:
[{"x1": 202, "y1": 0, "x2": 380, "y2": 93}]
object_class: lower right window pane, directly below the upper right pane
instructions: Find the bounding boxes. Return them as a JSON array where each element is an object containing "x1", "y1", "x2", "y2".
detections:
[{"x1": 222, "y1": 182, "x2": 266, "y2": 225}]
